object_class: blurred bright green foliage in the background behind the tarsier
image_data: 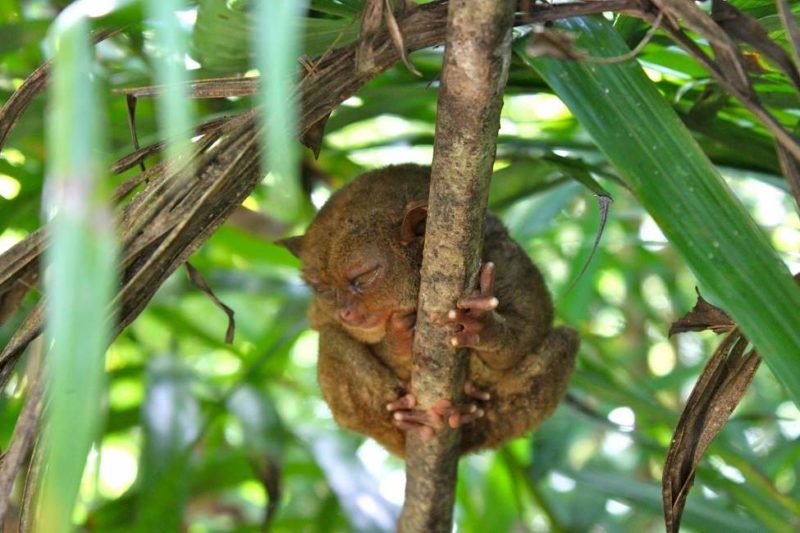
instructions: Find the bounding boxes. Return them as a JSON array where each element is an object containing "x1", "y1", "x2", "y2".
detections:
[{"x1": 0, "y1": 0, "x2": 800, "y2": 531}]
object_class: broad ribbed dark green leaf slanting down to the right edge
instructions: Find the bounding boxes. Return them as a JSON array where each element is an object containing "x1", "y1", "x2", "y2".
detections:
[{"x1": 516, "y1": 18, "x2": 800, "y2": 401}]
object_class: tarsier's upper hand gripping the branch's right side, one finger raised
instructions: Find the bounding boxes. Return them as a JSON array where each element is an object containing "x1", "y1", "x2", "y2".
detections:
[{"x1": 447, "y1": 262, "x2": 502, "y2": 348}]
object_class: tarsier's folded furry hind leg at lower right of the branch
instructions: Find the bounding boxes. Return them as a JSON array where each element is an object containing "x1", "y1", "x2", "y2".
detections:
[{"x1": 462, "y1": 327, "x2": 579, "y2": 453}]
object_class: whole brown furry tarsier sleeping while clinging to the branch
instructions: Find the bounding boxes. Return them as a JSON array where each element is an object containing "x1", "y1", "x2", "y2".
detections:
[{"x1": 279, "y1": 165, "x2": 579, "y2": 456}]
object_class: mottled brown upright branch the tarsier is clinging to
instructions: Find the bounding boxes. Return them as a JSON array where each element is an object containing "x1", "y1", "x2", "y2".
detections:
[{"x1": 399, "y1": 0, "x2": 515, "y2": 532}]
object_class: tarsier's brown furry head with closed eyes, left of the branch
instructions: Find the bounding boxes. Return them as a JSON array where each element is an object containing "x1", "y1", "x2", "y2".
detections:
[{"x1": 278, "y1": 167, "x2": 427, "y2": 343}]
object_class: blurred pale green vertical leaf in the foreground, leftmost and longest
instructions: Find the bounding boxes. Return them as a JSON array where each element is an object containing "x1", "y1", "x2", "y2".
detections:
[{"x1": 36, "y1": 9, "x2": 116, "y2": 532}]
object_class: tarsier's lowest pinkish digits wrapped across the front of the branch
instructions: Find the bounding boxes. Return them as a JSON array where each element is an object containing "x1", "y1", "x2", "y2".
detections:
[{"x1": 386, "y1": 381, "x2": 491, "y2": 441}]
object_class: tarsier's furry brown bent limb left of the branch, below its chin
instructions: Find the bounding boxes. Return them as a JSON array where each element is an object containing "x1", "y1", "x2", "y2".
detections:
[{"x1": 317, "y1": 324, "x2": 405, "y2": 456}]
